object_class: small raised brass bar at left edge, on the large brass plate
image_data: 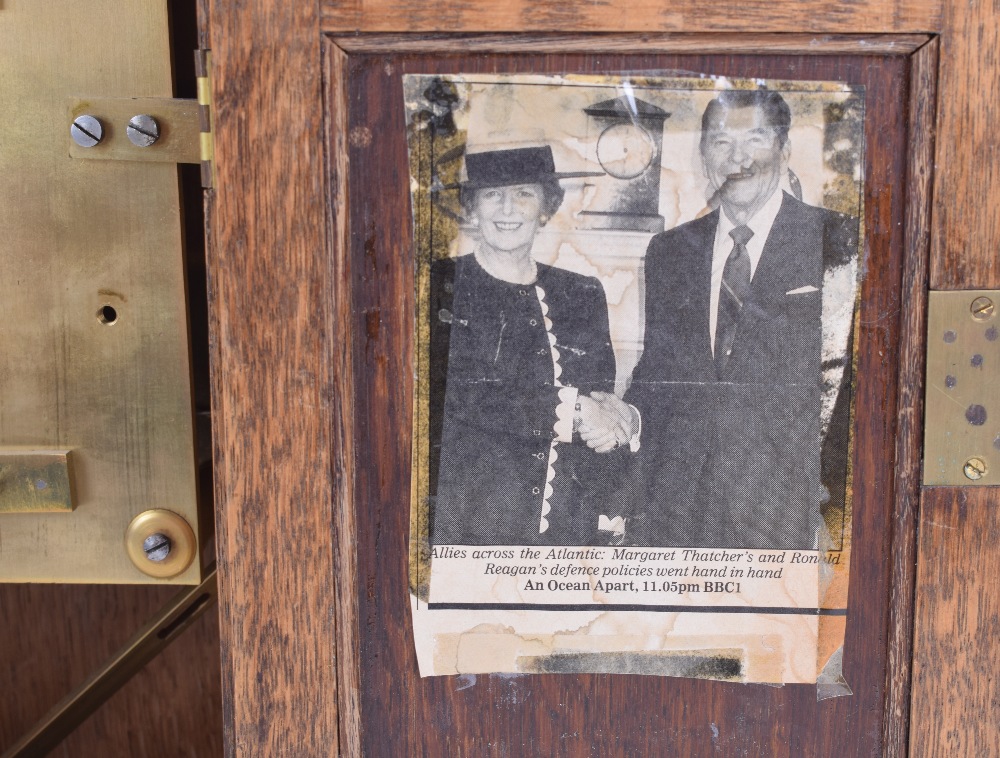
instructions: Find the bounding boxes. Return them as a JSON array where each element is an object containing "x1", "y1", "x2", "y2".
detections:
[{"x1": 0, "y1": 450, "x2": 73, "y2": 513}]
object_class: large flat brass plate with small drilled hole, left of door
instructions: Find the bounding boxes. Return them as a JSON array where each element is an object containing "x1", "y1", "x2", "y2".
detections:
[{"x1": 0, "y1": 0, "x2": 200, "y2": 584}]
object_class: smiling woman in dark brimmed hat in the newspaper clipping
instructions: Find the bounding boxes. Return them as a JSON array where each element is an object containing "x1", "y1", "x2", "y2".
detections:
[{"x1": 430, "y1": 146, "x2": 626, "y2": 545}]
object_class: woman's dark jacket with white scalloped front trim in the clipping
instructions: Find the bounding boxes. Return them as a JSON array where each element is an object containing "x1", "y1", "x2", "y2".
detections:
[{"x1": 430, "y1": 255, "x2": 615, "y2": 545}]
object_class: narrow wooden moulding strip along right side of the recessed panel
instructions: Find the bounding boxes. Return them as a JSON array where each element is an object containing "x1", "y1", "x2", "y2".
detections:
[{"x1": 885, "y1": 39, "x2": 938, "y2": 755}]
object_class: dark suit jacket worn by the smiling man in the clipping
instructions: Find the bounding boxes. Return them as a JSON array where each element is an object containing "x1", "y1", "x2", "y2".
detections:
[{"x1": 625, "y1": 194, "x2": 857, "y2": 549}]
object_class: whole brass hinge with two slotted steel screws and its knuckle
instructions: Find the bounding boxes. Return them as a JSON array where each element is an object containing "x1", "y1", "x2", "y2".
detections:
[{"x1": 68, "y1": 50, "x2": 215, "y2": 188}]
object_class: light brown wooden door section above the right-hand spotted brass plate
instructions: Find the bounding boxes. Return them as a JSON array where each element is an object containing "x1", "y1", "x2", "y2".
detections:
[{"x1": 931, "y1": 0, "x2": 1000, "y2": 289}]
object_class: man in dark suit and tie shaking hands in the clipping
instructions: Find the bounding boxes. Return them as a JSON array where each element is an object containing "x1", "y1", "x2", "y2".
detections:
[{"x1": 588, "y1": 90, "x2": 858, "y2": 549}]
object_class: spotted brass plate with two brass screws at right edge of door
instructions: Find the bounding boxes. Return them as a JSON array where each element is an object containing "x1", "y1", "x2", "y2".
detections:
[{"x1": 924, "y1": 290, "x2": 1000, "y2": 486}]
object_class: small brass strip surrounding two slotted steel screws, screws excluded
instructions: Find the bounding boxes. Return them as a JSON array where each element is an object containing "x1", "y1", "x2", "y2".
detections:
[{"x1": 66, "y1": 97, "x2": 201, "y2": 163}]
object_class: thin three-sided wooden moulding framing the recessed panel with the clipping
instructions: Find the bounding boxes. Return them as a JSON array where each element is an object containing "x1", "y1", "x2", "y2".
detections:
[{"x1": 314, "y1": 35, "x2": 937, "y2": 755}]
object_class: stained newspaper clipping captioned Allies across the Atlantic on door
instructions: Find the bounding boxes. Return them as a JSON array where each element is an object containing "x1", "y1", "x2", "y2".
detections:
[{"x1": 404, "y1": 74, "x2": 864, "y2": 697}]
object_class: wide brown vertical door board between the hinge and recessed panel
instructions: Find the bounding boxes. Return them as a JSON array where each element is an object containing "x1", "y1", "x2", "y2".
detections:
[{"x1": 208, "y1": 0, "x2": 342, "y2": 757}]
